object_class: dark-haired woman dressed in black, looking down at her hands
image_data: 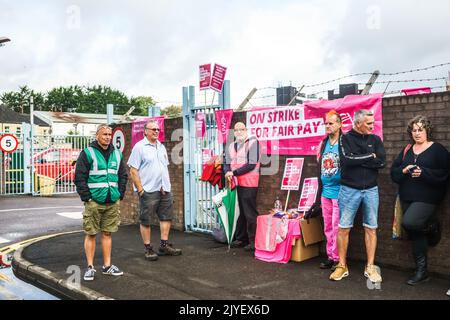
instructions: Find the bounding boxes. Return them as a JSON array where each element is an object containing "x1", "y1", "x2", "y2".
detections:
[{"x1": 391, "y1": 116, "x2": 450, "y2": 285}]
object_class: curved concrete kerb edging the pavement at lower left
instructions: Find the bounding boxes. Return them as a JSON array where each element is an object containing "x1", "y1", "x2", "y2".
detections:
[{"x1": 11, "y1": 231, "x2": 114, "y2": 300}]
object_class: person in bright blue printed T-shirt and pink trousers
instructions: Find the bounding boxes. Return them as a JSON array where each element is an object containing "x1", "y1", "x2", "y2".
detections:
[{"x1": 318, "y1": 110, "x2": 342, "y2": 270}]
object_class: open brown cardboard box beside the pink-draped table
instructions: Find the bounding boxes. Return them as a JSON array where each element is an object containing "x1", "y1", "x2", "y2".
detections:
[{"x1": 291, "y1": 217, "x2": 325, "y2": 262}]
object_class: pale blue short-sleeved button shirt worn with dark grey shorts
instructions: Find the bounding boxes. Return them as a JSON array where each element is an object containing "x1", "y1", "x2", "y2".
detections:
[{"x1": 127, "y1": 137, "x2": 171, "y2": 192}]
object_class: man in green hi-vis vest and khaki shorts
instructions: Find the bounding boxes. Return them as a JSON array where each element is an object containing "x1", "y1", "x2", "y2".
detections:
[{"x1": 75, "y1": 125, "x2": 128, "y2": 281}]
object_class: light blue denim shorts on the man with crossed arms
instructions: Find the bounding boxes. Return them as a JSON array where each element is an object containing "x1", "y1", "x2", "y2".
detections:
[{"x1": 338, "y1": 186, "x2": 379, "y2": 229}]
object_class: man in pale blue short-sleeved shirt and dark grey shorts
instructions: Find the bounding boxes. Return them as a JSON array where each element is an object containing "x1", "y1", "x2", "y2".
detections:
[{"x1": 128, "y1": 120, "x2": 181, "y2": 261}]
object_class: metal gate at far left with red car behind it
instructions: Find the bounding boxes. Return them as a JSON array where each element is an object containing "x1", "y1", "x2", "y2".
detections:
[{"x1": 0, "y1": 123, "x2": 94, "y2": 196}]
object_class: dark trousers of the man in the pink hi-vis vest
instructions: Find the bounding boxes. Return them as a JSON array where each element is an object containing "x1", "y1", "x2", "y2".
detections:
[{"x1": 235, "y1": 186, "x2": 258, "y2": 244}]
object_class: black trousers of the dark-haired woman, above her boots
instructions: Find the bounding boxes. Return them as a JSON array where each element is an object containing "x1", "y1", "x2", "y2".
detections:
[{"x1": 402, "y1": 201, "x2": 437, "y2": 257}]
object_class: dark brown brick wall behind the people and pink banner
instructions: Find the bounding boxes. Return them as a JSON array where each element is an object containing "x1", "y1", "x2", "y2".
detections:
[{"x1": 118, "y1": 92, "x2": 450, "y2": 276}]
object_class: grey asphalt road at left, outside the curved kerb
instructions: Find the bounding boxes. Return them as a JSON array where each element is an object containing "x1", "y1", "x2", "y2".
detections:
[{"x1": 0, "y1": 195, "x2": 83, "y2": 300}]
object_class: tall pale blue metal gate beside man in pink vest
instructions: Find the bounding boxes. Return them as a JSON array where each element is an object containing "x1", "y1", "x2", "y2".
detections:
[{"x1": 183, "y1": 80, "x2": 230, "y2": 233}]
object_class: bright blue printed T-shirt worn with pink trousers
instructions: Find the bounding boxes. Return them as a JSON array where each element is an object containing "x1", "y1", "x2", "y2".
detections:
[{"x1": 320, "y1": 139, "x2": 341, "y2": 199}]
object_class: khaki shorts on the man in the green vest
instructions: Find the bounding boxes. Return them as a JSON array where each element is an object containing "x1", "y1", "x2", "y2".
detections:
[{"x1": 83, "y1": 200, "x2": 120, "y2": 236}]
